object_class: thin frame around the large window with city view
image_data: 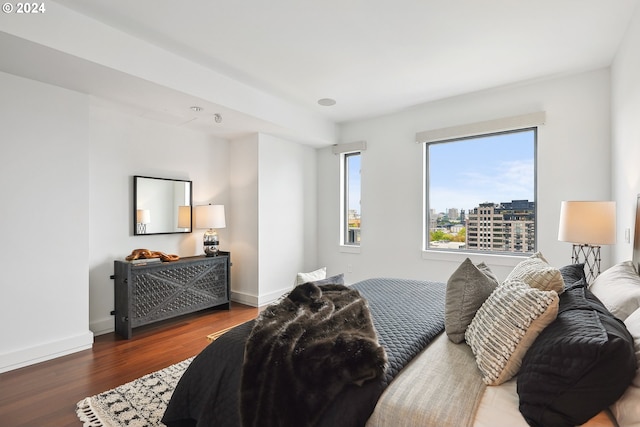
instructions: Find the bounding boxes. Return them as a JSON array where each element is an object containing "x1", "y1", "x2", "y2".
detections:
[{"x1": 422, "y1": 125, "x2": 539, "y2": 258}]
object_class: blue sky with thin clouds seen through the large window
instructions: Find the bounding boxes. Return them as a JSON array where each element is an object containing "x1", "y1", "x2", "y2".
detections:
[{"x1": 428, "y1": 131, "x2": 535, "y2": 212}]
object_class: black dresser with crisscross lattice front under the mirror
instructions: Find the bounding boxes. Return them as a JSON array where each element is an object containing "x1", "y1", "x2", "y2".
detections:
[{"x1": 112, "y1": 252, "x2": 231, "y2": 339}]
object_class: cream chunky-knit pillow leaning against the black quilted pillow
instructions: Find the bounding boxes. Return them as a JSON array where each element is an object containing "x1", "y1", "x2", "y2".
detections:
[{"x1": 465, "y1": 280, "x2": 558, "y2": 385}]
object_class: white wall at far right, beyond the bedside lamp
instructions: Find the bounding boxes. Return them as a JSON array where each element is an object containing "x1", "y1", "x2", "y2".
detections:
[{"x1": 611, "y1": 4, "x2": 640, "y2": 262}]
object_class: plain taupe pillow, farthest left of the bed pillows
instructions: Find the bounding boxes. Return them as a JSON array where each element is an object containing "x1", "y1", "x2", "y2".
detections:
[{"x1": 444, "y1": 258, "x2": 498, "y2": 344}]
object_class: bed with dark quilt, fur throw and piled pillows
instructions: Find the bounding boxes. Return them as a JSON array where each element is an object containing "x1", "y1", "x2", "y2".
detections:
[{"x1": 163, "y1": 211, "x2": 640, "y2": 427}]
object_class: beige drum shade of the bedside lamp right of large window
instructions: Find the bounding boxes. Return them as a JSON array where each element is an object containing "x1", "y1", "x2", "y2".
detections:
[{"x1": 558, "y1": 201, "x2": 616, "y2": 245}]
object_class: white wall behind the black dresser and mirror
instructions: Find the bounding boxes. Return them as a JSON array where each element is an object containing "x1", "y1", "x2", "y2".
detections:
[{"x1": 86, "y1": 99, "x2": 233, "y2": 333}]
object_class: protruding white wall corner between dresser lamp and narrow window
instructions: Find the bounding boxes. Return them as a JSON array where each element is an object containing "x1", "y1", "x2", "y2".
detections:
[{"x1": 231, "y1": 134, "x2": 316, "y2": 306}]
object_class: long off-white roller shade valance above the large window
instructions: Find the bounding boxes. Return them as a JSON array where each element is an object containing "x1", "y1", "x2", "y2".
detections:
[{"x1": 416, "y1": 111, "x2": 546, "y2": 143}]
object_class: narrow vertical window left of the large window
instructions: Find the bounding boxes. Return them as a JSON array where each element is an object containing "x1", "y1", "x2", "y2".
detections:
[{"x1": 341, "y1": 151, "x2": 361, "y2": 246}]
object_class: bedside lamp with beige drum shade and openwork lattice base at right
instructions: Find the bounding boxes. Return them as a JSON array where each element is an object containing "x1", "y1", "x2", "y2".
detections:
[{"x1": 558, "y1": 201, "x2": 616, "y2": 283}]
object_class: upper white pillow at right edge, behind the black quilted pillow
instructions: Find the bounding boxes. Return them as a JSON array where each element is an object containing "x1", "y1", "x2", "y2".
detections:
[{"x1": 589, "y1": 261, "x2": 640, "y2": 320}]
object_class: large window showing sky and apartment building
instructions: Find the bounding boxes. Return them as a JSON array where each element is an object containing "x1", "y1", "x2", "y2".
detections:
[{"x1": 425, "y1": 127, "x2": 537, "y2": 254}]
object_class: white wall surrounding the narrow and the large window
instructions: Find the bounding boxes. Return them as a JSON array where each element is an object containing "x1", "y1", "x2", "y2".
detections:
[{"x1": 318, "y1": 69, "x2": 611, "y2": 282}]
